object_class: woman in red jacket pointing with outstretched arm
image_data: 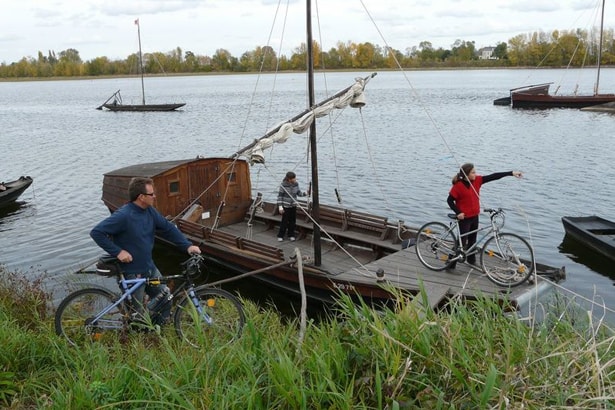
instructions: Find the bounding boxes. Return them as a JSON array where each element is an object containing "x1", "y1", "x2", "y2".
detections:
[{"x1": 446, "y1": 163, "x2": 523, "y2": 268}]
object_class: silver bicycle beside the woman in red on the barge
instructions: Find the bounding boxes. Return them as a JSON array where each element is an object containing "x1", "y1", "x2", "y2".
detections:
[{"x1": 415, "y1": 208, "x2": 536, "y2": 287}]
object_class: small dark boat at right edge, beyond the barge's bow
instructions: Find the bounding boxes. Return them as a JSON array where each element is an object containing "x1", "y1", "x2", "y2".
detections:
[{"x1": 562, "y1": 215, "x2": 615, "y2": 260}]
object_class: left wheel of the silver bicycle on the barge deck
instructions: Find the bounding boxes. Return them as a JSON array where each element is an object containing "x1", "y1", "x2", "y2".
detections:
[{"x1": 415, "y1": 222, "x2": 457, "y2": 270}]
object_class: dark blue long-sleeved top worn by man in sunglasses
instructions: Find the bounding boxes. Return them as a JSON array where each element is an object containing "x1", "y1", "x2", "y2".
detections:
[{"x1": 90, "y1": 202, "x2": 192, "y2": 274}]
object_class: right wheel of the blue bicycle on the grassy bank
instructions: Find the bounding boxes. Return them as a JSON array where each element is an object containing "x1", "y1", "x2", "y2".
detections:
[{"x1": 175, "y1": 287, "x2": 245, "y2": 347}]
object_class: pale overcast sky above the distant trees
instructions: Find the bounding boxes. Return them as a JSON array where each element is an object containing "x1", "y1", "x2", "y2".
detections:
[{"x1": 0, "y1": 0, "x2": 615, "y2": 63}]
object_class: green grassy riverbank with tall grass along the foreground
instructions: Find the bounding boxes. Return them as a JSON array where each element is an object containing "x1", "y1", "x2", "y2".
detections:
[{"x1": 0, "y1": 267, "x2": 615, "y2": 409}]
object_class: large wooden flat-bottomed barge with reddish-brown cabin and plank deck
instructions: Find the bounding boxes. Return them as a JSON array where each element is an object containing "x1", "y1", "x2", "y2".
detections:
[{"x1": 103, "y1": 158, "x2": 565, "y2": 309}]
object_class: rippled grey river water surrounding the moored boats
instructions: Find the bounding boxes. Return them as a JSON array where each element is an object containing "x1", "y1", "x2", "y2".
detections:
[{"x1": 0, "y1": 69, "x2": 615, "y2": 318}]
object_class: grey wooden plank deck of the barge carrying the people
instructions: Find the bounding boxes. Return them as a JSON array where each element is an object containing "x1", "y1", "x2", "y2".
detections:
[{"x1": 219, "y1": 216, "x2": 565, "y2": 308}]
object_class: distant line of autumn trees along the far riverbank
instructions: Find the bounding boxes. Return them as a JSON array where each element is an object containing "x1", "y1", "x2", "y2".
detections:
[{"x1": 0, "y1": 29, "x2": 615, "y2": 78}]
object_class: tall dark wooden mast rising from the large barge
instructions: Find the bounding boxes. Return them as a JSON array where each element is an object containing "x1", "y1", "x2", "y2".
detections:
[{"x1": 306, "y1": 0, "x2": 322, "y2": 266}]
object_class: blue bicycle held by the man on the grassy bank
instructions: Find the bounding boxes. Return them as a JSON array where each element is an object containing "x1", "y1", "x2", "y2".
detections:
[{"x1": 55, "y1": 254, "x2": 245, "y2": 347}]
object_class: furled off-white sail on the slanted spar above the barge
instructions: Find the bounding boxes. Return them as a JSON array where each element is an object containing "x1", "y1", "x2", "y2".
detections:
[{"x1": 236, "y1": 73, "x2": 375, "y2": 164}]
